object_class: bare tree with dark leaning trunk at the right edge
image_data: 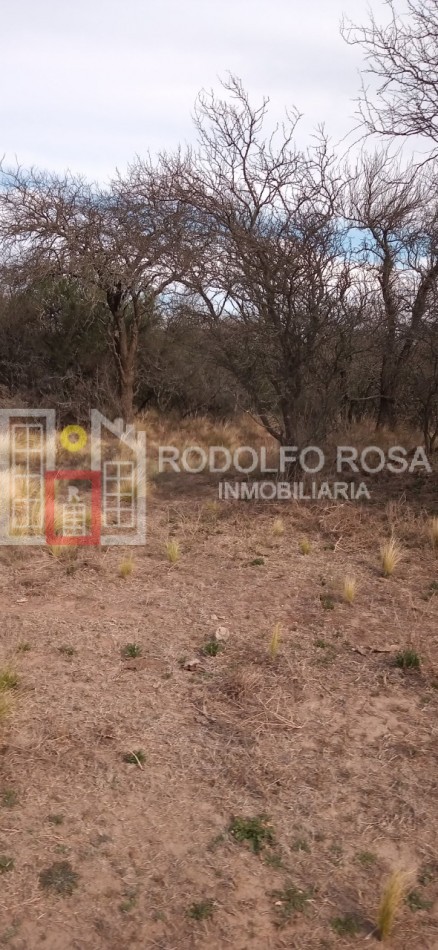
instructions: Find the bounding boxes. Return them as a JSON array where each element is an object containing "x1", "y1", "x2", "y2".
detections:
[{"x1": 344, "y1": 151, "x2": 438, "y2": 427}]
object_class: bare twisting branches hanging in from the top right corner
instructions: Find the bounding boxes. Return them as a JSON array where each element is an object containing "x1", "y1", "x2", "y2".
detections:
[{"x1": 342, "y1": 0, "x2": 438, "y2": 158}]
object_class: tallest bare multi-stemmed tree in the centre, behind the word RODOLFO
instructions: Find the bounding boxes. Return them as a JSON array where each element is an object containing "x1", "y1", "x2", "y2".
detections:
[{"x1": 157, "y1": 77, "x2": 356, "y2": 444}]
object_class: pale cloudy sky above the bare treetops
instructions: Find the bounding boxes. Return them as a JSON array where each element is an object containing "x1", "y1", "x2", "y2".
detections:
[{"x1": 0, "y1": 0, "x2": 396, "y2": 184}]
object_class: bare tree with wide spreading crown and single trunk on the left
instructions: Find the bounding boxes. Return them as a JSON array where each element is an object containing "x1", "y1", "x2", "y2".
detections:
[{"x1": 0, "y1": 162, "x2": 186, "y2": 420}]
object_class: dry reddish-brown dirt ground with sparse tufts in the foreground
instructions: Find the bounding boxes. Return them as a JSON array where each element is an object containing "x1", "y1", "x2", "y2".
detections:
[{"x1": 0, "y1": 462, "x2": 438, "y2": 950}]
